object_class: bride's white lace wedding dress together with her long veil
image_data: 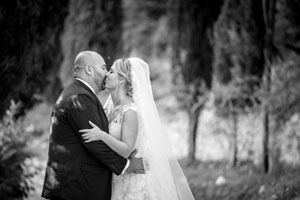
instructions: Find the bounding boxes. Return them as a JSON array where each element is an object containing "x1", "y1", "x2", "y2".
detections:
[{"x1": 103, "y1": 58, "x2": 194, "y2": 200}]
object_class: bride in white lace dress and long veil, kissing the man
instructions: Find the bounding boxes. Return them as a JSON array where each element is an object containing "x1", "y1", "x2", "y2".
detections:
[{"x1": 80, "y1": 58, "x2": 194, "y2": 200}]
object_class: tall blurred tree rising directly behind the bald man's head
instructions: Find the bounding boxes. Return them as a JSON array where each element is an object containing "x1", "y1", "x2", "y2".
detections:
[{"x1": 60, "y1": 0, "x2": 123, "y2": 86}]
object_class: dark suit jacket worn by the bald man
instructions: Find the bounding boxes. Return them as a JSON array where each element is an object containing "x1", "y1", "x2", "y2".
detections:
[{"x1": 42, "y1": 80, "x2": 127, "y2": 200}]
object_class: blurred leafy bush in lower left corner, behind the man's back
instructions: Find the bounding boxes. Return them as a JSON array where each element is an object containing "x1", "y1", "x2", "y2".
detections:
[{"x1": 0, "y1": 102, "x2": 38, "y2": 200}]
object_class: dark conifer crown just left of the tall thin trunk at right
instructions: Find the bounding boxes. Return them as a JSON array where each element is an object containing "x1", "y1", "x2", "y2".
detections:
[{"x1": 213, "y1": 0, "x2": 263, "y2": 86}]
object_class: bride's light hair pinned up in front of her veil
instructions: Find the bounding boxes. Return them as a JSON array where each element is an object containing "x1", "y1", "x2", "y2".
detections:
[{"x1": 113, "y1": 58, "x2": 132, "y2": 97}]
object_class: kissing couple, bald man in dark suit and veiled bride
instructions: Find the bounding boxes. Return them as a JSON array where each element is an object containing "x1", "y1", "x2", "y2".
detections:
[{"x1": 42, "y1": 51, "x2": 194, "y2": 200}]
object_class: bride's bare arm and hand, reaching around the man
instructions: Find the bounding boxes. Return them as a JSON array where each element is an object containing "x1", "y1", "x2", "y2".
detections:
[{"x1": 79, "y1": 110, "x2": 138, "y2": 158}]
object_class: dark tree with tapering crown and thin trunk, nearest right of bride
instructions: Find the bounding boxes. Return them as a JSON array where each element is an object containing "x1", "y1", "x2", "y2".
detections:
[{"x1": 169, "y1": 0, "x2": 223, "y2": 161}]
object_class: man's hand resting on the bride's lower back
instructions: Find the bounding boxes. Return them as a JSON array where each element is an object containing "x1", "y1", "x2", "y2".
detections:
[{"x1": 126, "y1": 149, "x2": 149, "y2": 174}]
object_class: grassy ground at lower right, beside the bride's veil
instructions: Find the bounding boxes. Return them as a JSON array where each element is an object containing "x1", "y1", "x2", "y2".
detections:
[{"x1": 181, "y1": 161, "x2": 300, "y2": 200}]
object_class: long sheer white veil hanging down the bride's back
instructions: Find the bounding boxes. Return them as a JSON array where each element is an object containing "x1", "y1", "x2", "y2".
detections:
[{"x1": 128, "y1": 57, "x2": 194, "y2": 200}]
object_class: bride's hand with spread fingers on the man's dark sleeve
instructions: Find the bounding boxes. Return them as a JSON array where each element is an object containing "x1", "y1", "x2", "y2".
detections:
[{"x1": 79, "y1": 121, "x2": 106, "y2": 142}]
